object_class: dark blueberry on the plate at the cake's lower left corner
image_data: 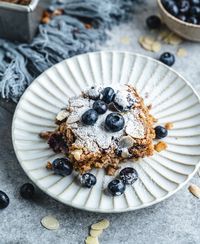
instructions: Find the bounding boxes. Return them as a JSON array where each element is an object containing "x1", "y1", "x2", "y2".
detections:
[{"x1": 52, "y1": 158, "x2": 73, "y2": 176}]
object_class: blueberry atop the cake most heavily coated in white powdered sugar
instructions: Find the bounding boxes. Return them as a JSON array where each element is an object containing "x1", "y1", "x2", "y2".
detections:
[{"x1": 113, "y1": 91, "x2": 135, "y2": 112}]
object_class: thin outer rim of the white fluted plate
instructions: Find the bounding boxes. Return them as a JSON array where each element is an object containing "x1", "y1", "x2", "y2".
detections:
[{"x1": 11, "y1": 50, "x2": 200, "y2": 213}]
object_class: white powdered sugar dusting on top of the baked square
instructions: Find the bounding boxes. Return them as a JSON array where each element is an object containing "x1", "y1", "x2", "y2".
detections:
[{"x1": 61, "y1": 85, "x2": 145, "y2": 152}]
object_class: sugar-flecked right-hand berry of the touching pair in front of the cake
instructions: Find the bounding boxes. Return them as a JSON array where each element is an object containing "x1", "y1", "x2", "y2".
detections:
[{"x1": 119, "y1": 167, "x2": 138, "y2": 185}]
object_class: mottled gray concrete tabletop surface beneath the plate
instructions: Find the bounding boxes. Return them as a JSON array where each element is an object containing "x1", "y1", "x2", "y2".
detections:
[{"x1": 0, "y1": 0, "x2": 200, "y2": 244}]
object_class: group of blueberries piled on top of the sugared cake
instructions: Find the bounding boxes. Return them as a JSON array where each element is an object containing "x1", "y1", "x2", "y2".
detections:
[{"x1": 81, "y1": 87, "x2": 134, "y2": 132}]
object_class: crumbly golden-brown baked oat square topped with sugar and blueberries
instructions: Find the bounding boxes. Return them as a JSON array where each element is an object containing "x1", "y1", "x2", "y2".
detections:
[{"x1": 40, "y1": 86, "x2": 155, "y2": 175}]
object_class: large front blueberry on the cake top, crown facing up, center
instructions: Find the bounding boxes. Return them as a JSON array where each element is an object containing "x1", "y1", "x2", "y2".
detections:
[{"x1": 105, "y1": 113, "x2": 125, "y2": 132}]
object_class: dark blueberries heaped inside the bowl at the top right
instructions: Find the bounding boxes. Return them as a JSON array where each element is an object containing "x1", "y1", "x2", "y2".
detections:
[{"x1": 162, "y1": 0, "x2": 200, "y2": 25}]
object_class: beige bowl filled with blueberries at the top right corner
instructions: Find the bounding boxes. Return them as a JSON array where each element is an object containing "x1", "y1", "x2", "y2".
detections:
[{"x1": 157, "y1": 0, "x2": 200, "y2": 41}]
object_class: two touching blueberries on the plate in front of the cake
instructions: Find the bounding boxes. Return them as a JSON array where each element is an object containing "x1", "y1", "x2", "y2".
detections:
[{"x1": 108, "y1": 167, "x2": 138, "y2": 196}]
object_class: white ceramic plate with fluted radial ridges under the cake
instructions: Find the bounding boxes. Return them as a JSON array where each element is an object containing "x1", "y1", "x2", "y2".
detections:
[{"x1": 12, "y1": 52, "x2": 200, "y2": 212}]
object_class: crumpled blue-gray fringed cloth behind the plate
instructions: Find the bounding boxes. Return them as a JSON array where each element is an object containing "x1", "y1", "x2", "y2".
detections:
[{"x1": 0, "y1": 0, "x2": 141, "y2": 102}]
